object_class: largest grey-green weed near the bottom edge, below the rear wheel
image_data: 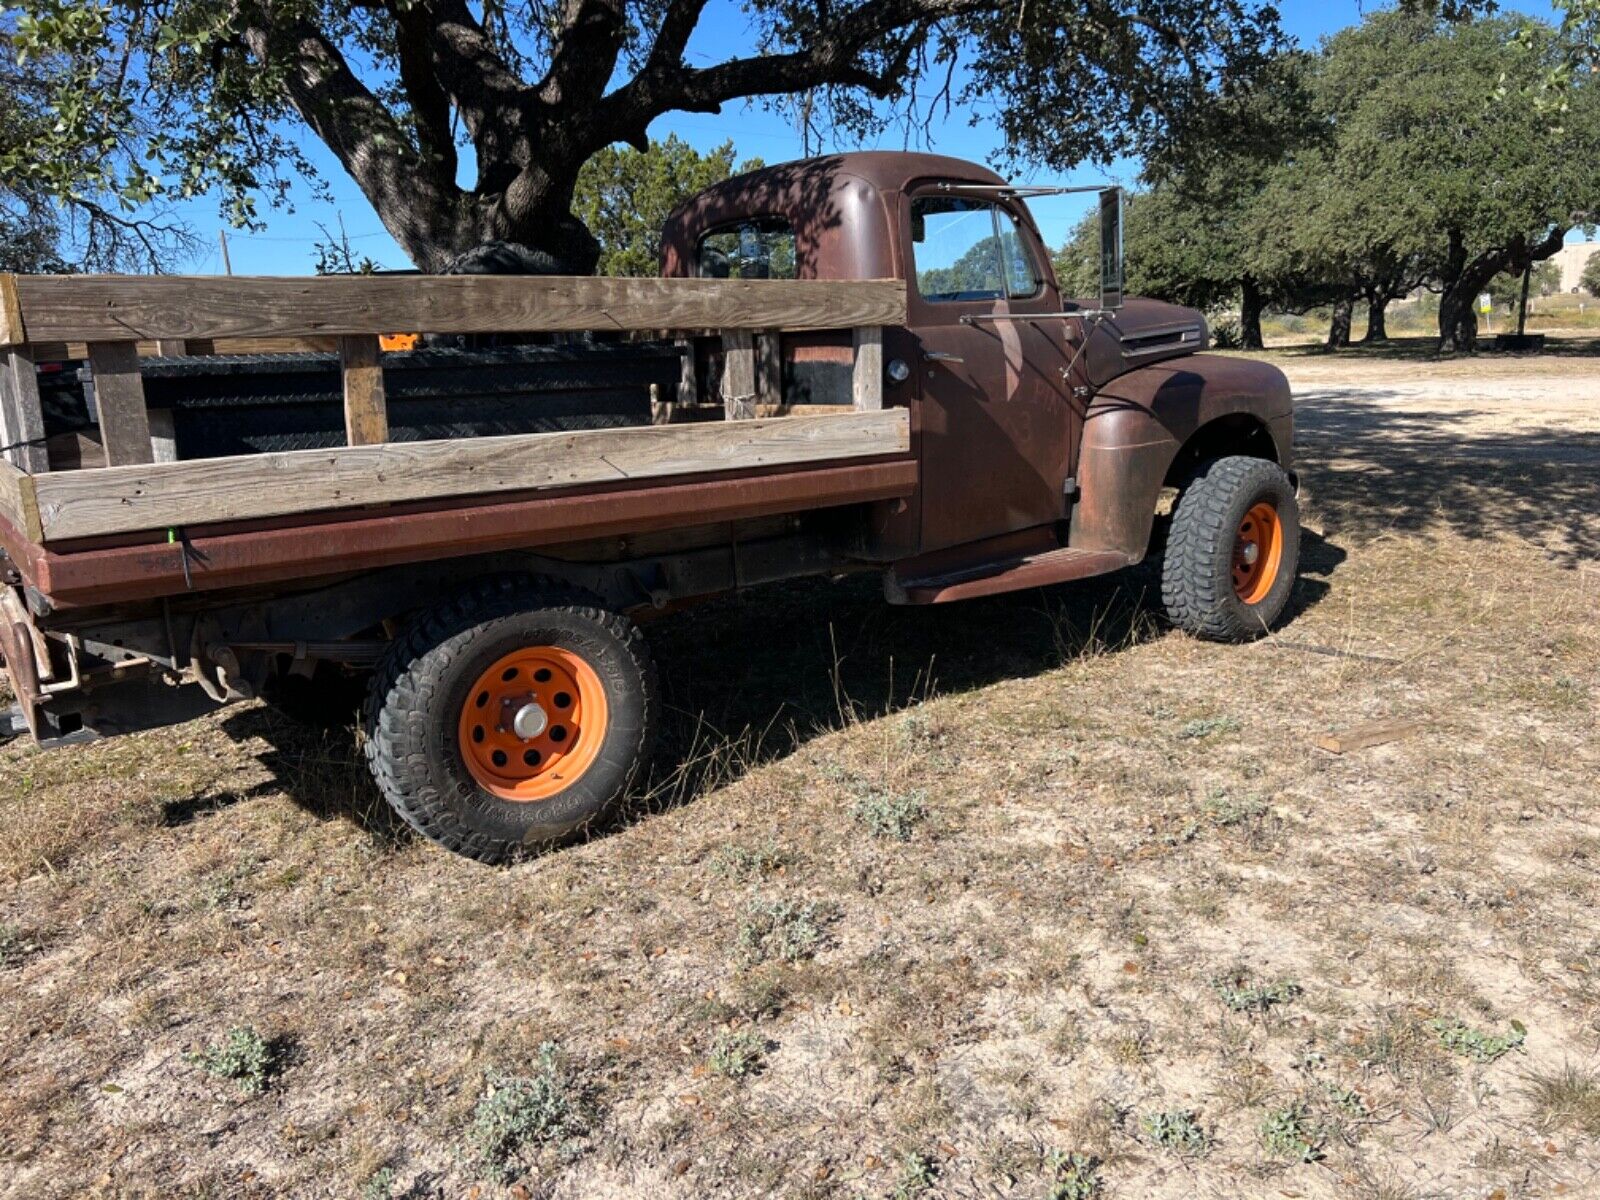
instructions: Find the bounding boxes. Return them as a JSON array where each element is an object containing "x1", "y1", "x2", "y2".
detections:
[{"x1": 462, "y1": 1042, "x2": 589, "y2": 1182}]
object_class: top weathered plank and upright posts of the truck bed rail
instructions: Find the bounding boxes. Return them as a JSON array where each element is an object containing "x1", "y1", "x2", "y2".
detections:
[{"x1": 0, "y1": 275, "x2": 906, "y2": 475}]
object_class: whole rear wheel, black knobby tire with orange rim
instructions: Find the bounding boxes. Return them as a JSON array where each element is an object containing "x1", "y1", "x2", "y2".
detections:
[{"x1": 365, "y1": 578, "x2": 656, "y2": 862}]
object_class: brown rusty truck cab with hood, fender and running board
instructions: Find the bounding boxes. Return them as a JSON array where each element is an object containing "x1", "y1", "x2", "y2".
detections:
[{"x1": 662, "y1": 152, "x2": 1293, "y2": 603}]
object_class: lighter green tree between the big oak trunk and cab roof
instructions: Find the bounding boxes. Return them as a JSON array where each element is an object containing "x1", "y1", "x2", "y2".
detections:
[{"x1": 573, "y1": 134, "x2": 762, "y2": 275}]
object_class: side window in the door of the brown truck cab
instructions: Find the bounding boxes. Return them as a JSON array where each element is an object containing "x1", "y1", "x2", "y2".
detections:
[{"x1": 910, "y1": 195, "x2": 1040, "y2": 301}]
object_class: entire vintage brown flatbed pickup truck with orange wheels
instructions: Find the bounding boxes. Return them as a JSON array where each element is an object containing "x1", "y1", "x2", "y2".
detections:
[{"x1": 0, "y1": 154, "x2": 1299, "y2": 862}]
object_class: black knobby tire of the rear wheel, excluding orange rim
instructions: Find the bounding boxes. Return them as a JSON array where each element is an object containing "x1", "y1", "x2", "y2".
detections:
[{"x1": 363, "y1": 576, "x2": 658, "y2": 864}]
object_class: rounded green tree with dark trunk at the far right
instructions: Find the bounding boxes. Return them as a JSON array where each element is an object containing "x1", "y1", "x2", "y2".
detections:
[{"x1": 1318, "y1": 13, "x2": 1600, "y2": 354}]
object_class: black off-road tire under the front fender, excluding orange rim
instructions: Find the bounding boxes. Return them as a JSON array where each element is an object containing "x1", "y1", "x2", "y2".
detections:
[{"x1": 1162, "y1": 458, "x2": 1299, "y2": 642}]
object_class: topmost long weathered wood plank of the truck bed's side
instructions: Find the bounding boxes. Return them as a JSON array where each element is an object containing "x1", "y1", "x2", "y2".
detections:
[{"x1": 5, "y1": 275, "x2": 906, "y2": 342}]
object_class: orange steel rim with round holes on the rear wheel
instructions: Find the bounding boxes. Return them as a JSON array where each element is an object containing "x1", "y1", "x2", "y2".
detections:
[{"x1": 458, "y1": 646, "x2": 610, "y2": 803}]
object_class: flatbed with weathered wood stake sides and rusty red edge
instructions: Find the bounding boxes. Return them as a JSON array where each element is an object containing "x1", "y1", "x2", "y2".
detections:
[{"x1": 0, "y1": 277, "x2": 917, "y2": 610}]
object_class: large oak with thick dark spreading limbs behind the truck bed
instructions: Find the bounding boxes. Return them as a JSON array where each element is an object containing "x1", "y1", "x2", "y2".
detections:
[{"x1": 0, "y1": 0, "x2": 1282, "y2": 272}]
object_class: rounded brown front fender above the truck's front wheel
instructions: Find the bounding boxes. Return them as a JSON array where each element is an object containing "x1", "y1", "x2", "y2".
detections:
[{"x1": 1069, "y1": 354, "x2": 1294, "y2": 562}]
